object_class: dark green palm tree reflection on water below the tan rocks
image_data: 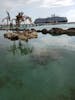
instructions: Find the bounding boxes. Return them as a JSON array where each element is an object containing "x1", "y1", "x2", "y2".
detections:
[{"x1": 9, "y1": 40, "x2": 33, "y2": 55}]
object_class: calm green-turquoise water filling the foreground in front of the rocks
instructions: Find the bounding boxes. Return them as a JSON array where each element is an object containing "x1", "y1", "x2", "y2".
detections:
[{"x1": 0, "y1": 31, "x2": 75, "y2": 100}]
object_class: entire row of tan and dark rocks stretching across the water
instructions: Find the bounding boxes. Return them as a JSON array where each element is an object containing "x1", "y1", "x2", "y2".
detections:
[{"x1": 4, "y1": 28, "x2": 75, "y2": 41}]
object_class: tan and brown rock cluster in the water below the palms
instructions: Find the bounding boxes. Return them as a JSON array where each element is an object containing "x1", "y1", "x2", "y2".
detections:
[{"x1": 4, "y1": 30, "x2": 38, "y2": 41}]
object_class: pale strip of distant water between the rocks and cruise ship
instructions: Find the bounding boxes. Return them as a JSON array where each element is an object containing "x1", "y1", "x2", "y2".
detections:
[{"x1": 0, "y1": 22, "x2": 75, "y2": 31}]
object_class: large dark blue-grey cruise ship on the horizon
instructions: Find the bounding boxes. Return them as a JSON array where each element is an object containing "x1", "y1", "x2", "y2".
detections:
[{"x1": 34, "y1": 15, "x2": 68, "y2": 24}]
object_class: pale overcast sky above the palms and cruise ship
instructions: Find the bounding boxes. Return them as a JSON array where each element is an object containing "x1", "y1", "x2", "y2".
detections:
[{"x1": 0, "y1": 0, "x2": 75, "y2": 21}]
